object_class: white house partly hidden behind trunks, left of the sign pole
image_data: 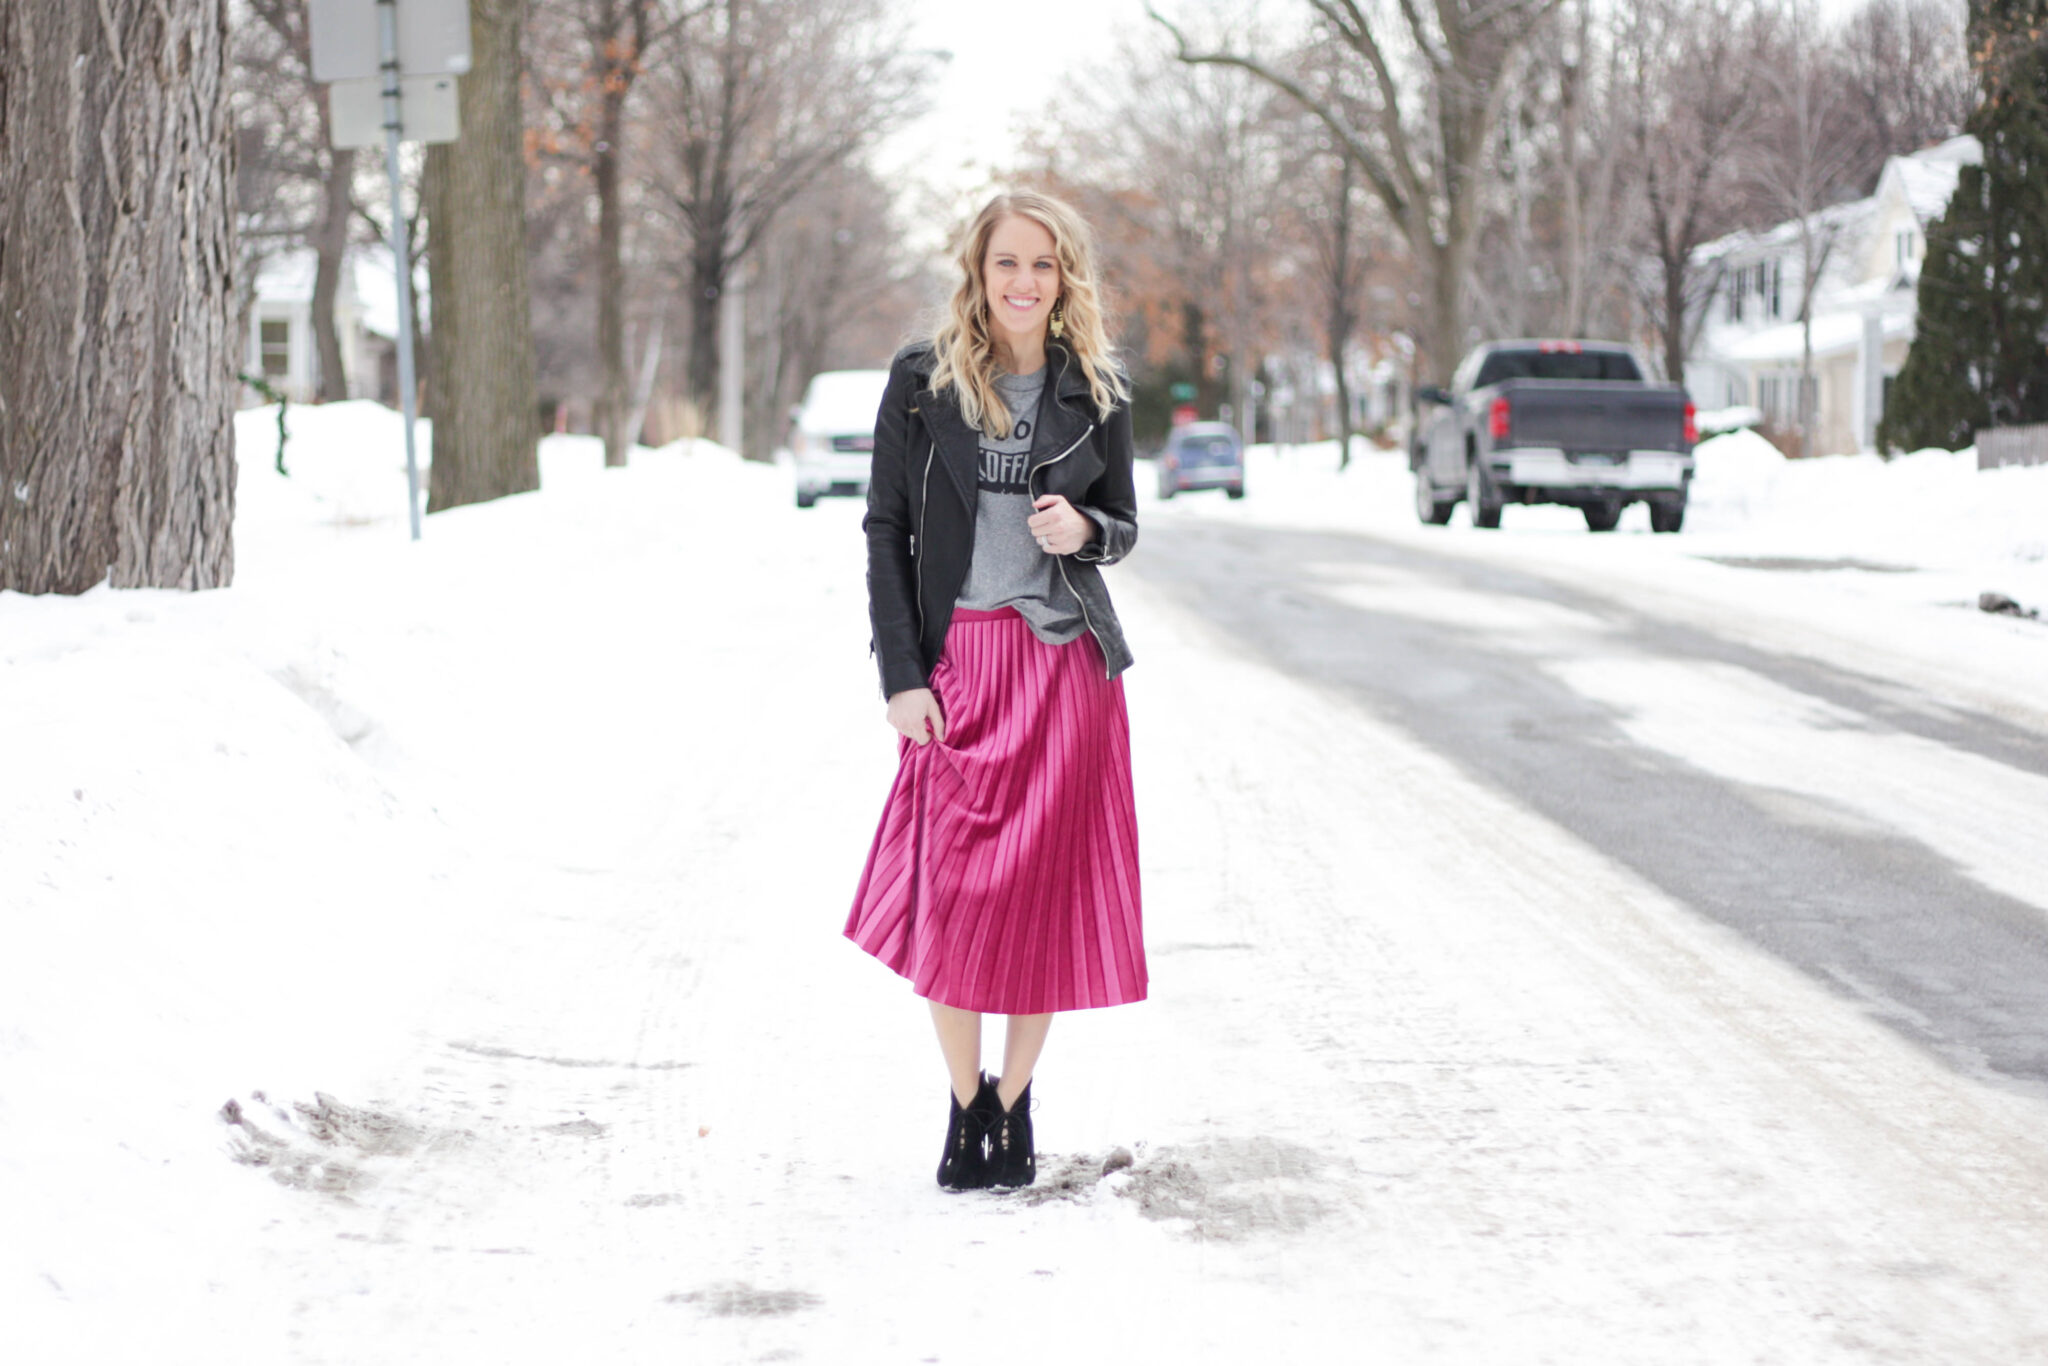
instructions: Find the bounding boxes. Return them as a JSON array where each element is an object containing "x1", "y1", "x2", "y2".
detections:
[{"x1": 242, "y1": 246, "x2": 397, "y2": 408}]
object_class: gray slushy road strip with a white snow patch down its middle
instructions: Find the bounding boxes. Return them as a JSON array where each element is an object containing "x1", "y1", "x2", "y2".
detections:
[{"x1": 1133, "y1": 520, "x2": 2048, "y2": 1096}]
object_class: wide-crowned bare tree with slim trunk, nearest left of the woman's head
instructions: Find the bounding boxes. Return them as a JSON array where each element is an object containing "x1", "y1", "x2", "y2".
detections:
[{"x1": 649, "y1": 0, "x2": 924, "y2": 428}]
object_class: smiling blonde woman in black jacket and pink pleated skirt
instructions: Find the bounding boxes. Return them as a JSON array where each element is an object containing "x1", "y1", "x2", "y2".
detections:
[{"x1": 846, "y1": 193, "x2": 1145, "y2": 1190}]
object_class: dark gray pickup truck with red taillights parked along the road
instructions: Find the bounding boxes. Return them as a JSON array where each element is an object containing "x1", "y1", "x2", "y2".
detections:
[{"x1": 1409, "y1": 342, "x2": 1698, "y2": 530}]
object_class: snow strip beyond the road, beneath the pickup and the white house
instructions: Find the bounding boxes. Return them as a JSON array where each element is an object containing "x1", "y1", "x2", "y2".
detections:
[{"x1": 1179, "y1": 432, "x2": 2048, "y2": 725}]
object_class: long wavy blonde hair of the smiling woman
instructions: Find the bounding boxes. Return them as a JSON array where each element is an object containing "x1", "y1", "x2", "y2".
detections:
[{"x1": 932, "y1": 190, "x2": 1130, "y2": 438}]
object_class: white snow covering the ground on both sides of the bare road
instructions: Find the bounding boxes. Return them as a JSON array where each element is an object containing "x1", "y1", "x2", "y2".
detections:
[{"x1": 0, "y1": 403, "x2": 2048, "y2": 1364}]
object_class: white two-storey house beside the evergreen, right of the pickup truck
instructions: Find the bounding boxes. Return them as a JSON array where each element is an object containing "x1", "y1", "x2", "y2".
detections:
[{"x1": 1686, "y1": 135, "x2": 1982, "y2": 455}]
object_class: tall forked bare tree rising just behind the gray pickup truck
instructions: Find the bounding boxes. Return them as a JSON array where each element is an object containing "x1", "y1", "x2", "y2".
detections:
[{"x1": 1147, "y1": 0, "x2": 1559, "y2": 381}]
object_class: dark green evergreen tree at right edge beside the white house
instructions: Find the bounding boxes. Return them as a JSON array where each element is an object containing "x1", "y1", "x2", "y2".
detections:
[{"x1": 1878, "y1": 0, "x2": 2048, "y2": 451}]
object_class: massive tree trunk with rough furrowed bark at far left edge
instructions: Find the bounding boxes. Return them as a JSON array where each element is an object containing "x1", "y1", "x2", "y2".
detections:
[{"x1": 0, "y1": 0, "x2": 240, "y2": 592}]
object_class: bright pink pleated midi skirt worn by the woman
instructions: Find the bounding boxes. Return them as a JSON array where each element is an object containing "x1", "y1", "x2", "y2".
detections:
[{"x1": 846, "y1": 608, "x2": 1145, "y2": 1016}]
